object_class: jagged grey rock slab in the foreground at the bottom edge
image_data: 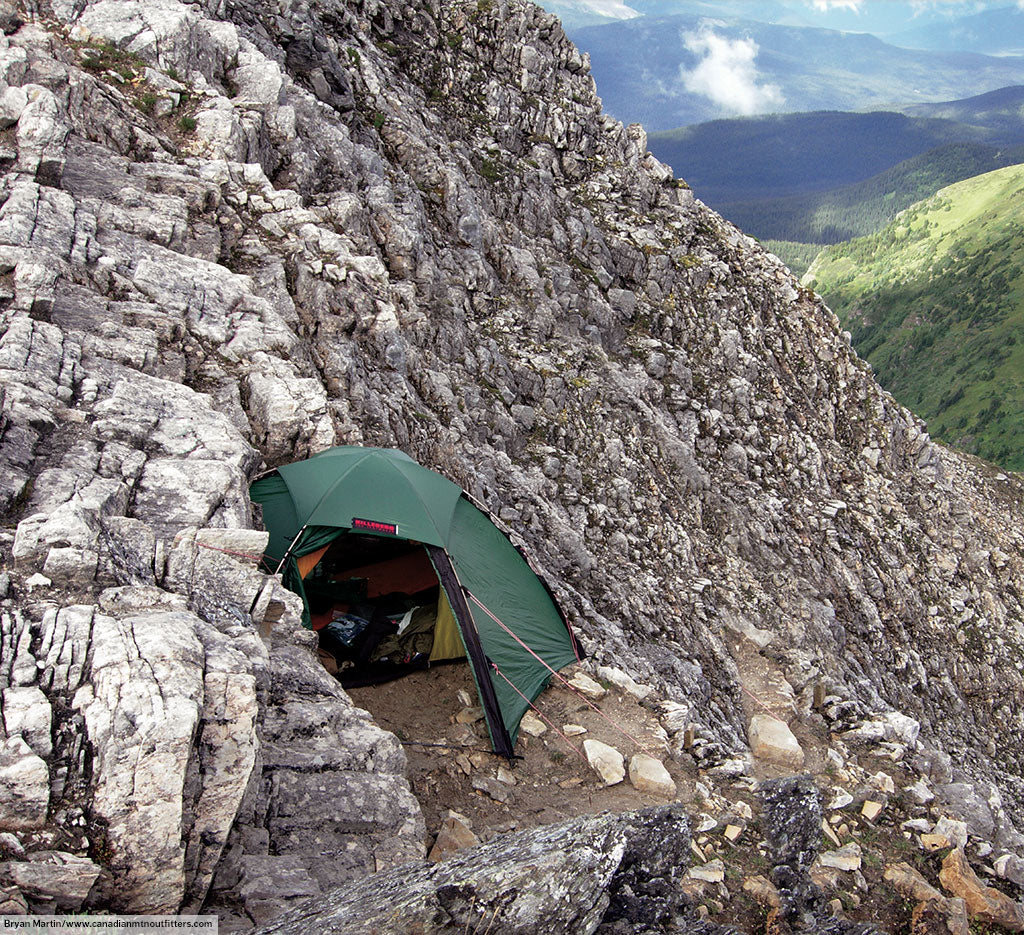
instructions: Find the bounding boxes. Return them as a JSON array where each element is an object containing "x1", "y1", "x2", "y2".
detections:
[{"x1": 258, "y1": 806, "x2": 690, "y2": 935}]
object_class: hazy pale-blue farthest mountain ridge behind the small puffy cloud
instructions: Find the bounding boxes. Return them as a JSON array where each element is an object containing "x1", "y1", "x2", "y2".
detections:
[{"x1": 570, "y1": 13, "x2": 1024, "y2": 131}]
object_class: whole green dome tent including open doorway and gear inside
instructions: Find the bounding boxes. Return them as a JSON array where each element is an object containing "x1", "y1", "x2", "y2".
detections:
[{"x1": 250, "y1": 447, "x2": 581, "y2": 757}]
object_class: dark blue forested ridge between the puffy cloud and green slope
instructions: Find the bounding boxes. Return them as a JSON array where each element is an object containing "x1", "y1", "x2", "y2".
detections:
[{"x1": 650, "y1": 85, "x2": 1024, "y2": 271}]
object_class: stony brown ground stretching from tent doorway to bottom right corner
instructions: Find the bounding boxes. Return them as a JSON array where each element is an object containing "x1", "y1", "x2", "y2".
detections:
[{"x1": 350, "y1": 651, "x2": 1024, "y2": 935}]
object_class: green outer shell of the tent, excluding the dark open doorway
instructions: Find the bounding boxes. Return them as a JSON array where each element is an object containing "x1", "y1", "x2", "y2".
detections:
[{"x1": 250, "y1": 447, "x2": 581, "y2": 757}]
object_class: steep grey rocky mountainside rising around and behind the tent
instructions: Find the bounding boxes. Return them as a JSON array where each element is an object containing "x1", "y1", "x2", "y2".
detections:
[{"x1": 0, "y1": 0, "x2": 1024, "y2": 932}]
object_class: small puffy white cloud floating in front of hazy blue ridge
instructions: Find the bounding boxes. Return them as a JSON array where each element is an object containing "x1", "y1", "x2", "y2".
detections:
[{"x1": 680, "y1": 28, "x2": 784, "y2": 117}]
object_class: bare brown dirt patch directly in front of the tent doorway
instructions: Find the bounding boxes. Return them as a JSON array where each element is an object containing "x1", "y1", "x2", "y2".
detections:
[{"x1": 349, "y1": 663, "x2": 695, "y2": 840}]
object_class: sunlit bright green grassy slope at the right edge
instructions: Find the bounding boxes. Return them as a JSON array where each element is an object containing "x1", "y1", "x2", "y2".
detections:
[{"x1": 807, "y1": 159, "x2": 1024, "y2": 470}]
